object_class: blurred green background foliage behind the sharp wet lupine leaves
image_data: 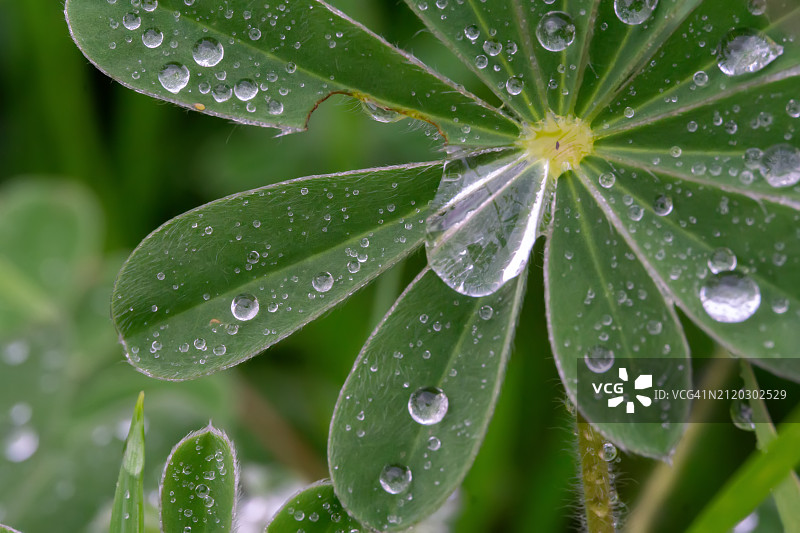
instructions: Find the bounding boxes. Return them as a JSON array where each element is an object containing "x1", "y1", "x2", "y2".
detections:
[{"x1": 0, "y1": 0, "x2": 792, "y2": 533}]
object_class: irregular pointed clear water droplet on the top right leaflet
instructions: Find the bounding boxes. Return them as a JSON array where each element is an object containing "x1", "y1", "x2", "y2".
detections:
[{"x1": 717, "y1": 29, "x2": 783, "y2": 76}]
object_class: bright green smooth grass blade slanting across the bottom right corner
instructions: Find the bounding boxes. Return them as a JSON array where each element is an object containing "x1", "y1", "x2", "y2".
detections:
[{"x1": 688, "y1": 408, "x2": 800, "y2": 533}]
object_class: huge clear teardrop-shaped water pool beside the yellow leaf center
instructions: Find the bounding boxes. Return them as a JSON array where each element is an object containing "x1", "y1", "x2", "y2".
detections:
[{"x1": 425, "y1": 150, "x2": 551, "y2": 296}]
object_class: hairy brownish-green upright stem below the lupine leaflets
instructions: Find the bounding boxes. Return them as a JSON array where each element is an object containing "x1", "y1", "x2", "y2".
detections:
[{"x1": 577, "y1": 413, "x2": 616, "y2": 533}]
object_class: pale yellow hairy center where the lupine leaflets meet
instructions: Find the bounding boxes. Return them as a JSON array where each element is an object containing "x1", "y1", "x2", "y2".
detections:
[{"x1": 517, "y1": 114, "x2": 594, "y2": 179}]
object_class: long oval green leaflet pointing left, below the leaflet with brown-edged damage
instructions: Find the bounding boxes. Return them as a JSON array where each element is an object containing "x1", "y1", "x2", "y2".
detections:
[{"x1": 112, "y1": 163, "x2": 442, "y2": 380}]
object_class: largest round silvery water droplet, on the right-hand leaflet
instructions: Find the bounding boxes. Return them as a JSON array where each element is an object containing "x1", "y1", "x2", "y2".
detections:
[{"x1": 700, "y1": 272, "x2": 761, "y2": 323}]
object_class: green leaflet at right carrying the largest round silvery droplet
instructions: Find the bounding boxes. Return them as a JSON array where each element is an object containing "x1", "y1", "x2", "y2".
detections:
[{"x1": 579, "y1": 158, "x2": 800, "y2": 379}]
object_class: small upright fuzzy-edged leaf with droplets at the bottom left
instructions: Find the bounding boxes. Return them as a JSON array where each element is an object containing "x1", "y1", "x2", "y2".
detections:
[{"x1": 161, "y1": 424, "x2": 239, "y2": 533}]
